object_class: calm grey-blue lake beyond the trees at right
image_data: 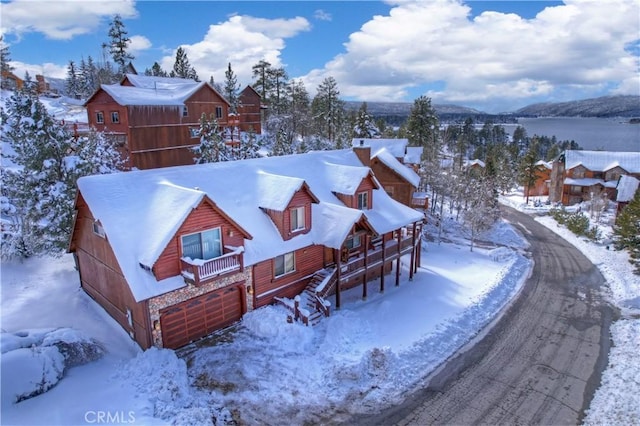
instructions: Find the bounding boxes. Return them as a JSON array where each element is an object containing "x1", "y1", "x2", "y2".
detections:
[{"x1": 503, "y1": 117, "x2": 640, "y2": 151}]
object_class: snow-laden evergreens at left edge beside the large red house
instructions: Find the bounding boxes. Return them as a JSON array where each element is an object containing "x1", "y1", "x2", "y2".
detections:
[{"x1": 0, "y1": 88, "x2": 121, "y2": 257}]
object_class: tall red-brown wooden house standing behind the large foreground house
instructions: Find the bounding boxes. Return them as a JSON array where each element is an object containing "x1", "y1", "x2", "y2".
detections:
[{"x1": 85, "y1": 74, "x2": 261, "y2": 169}]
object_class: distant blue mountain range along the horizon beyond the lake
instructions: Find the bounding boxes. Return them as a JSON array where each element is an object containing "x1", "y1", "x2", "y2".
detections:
[{"x1": 346, "y1": 95, "x2": 640, "y2": 119}]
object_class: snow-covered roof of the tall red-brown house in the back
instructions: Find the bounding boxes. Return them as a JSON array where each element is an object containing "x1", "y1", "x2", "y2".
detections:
[{"x1": 101, "y1": 80, "x2": 207, "y2": 106}]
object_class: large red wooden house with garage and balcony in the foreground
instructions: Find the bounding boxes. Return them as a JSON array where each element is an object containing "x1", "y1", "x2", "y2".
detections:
[{"x1": 70, "y1": 150, "x2": 423, "y2": 348}]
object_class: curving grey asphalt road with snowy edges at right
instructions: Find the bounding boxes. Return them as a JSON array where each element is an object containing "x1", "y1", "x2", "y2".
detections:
[{"x1": 353, "y1": 207, "x2": 616, "y2": 425}]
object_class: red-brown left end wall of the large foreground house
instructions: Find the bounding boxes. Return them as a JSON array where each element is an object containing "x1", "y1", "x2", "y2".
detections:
[{"x1": 71, "y1": 196, "x2": 152, "y2": 349}]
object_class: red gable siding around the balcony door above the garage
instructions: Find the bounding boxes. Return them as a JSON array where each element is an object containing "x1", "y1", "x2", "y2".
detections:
[{"x1": 153, "y1": 200, "x2": 244, "y2": 281}]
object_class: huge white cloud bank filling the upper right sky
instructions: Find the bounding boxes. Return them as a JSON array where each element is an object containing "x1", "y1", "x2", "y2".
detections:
[{"x1": 303, "y1": 0, "x2": 640, "y2": 111}]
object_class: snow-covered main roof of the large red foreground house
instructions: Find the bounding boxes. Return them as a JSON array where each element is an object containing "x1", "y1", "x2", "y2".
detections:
[{"x1": 78, "y1": 150, "x2": 422, "y2": 301}]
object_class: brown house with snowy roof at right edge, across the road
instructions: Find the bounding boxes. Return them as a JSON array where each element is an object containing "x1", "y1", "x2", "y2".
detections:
[{"x1": 549, "y1": 150, "x2": 640, "y2": 205}]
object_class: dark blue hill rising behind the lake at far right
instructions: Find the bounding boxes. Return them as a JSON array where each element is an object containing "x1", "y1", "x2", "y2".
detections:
[{"x1": 514, "y1": 96, "x2": 640, "y2": 117}]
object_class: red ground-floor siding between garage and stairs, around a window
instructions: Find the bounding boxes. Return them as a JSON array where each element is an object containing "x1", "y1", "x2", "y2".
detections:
[{"x1": 253, "y1": 245, "x2": 324, "y2": 307}]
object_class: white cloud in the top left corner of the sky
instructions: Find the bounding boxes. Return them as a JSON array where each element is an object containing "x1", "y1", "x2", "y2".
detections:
[{"x1": 0, "y1": 0, "x2": 137, "y2": 40}]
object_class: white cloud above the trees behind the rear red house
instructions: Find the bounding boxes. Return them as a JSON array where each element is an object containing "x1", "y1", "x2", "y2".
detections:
[{"x1": 160, "y1": 15, "x2": 311, "y2": 85}]
